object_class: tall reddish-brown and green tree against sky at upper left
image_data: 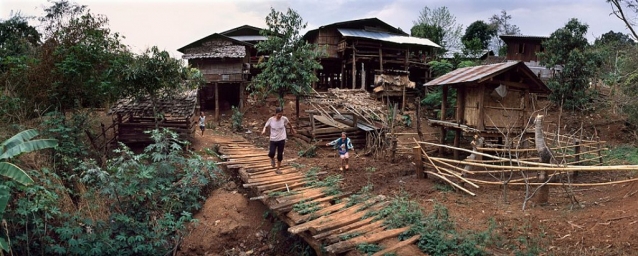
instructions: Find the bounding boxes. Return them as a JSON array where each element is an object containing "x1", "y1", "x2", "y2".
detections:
[{"x1": 40, "y1": 0, "x2": 127, "y2": 111}]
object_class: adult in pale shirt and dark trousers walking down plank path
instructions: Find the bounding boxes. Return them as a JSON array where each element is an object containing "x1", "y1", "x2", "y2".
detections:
[{"x1": 261, "y1": 108, "x2": 295, "y2": 174}]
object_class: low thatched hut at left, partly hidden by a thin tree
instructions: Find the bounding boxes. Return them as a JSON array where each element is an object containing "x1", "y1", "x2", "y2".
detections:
[{"x1": 108, "y1": 90, "x2": 198, "y2": 144}]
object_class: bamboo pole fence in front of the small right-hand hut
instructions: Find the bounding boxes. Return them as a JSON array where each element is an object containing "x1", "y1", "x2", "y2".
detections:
[{"x1": 415, "y1": 134, "x2": 638, "y2": 196}]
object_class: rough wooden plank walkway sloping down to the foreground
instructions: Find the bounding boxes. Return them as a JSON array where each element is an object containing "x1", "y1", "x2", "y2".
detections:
[{"x1": 216, "y1": 139, "x2": 419, "y2": 255}]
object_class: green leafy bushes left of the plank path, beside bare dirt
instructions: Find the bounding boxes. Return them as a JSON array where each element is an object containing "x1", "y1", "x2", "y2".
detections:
[{"x1": 5, "y1": 130, "x2": 222, "y2": 255}]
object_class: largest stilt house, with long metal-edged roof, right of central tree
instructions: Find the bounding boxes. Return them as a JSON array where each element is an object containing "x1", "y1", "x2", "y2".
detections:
[{"x1": 304, "y1": 18, "x2": 440, "y2": 111}]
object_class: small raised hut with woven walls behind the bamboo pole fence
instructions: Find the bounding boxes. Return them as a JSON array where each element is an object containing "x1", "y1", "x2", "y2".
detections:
[{"x1": 425, "y1": 61, "x2": 550, "y2": 158}]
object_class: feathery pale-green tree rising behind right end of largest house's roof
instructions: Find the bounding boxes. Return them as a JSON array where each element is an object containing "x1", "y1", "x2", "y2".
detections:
[{"x1": 410, "y1": 6, "x2": 463, "y2": 54}]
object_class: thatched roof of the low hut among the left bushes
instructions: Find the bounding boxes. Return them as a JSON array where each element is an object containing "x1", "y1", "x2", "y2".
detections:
[{"x1": 108, "y1": 90, "x2": 197, "y2": 120}]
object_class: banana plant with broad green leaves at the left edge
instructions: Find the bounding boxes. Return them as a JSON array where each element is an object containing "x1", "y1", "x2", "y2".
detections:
[{"x1": 0, "y1": 129, "x2": 58, "y2": 252}]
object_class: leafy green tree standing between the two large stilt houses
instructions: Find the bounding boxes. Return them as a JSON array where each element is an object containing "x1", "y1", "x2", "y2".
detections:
[{"x1": 249, "y1": 8, "x2": 323, "y2": 106}]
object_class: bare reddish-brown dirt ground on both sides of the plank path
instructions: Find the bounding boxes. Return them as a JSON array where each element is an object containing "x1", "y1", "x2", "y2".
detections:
[{"x1": 179, "y1": 96, "x2": 638, "y2": 255}]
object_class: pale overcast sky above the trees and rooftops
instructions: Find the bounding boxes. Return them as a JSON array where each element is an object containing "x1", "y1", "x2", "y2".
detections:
[{"x1": 0, "y1": 0, "x2": 629, "y2": 58}]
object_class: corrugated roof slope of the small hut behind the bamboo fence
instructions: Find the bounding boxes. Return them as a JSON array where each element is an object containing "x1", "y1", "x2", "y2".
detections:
[{"x1": 425, "y1": 61, "x2": 519, "y2": 86}]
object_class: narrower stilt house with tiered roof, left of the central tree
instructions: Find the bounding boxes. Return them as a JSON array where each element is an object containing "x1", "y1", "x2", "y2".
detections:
[{"x1": 178, "y1": 25, "x2": 266, "y2": 119}]
